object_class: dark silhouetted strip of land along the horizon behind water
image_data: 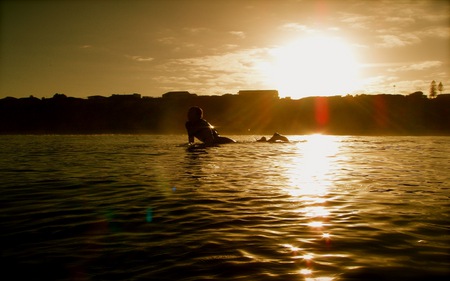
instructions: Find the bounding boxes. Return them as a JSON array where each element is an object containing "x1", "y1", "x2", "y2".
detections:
[{"x1": 0, "y1": 90, "x2": 450, "y2": 135}]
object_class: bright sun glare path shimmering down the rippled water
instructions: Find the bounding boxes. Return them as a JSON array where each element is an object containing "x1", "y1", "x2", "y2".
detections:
[{"x1": 283, "y1": 135, "x2": 340, "y2": 281}]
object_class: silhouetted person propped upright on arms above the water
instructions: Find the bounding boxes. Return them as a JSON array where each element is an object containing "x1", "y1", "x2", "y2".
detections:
[{"x1": 186, "y1": 106, "x2": 236, "y2": 146}]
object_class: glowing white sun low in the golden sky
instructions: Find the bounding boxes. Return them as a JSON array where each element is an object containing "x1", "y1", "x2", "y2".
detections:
[{"x1": 260, "y1": 35, "x2": 358, "y2": 99}]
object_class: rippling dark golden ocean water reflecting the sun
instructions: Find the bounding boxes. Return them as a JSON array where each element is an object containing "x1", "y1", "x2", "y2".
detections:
[{"x1": 0, "y1": 135, "x2": 450, "y2": 281}]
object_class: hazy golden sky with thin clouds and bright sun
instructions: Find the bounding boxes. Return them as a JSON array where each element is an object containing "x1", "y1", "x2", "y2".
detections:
[{"x1": 0, "y1": 0, "x2": 450, "y2": 99}]
